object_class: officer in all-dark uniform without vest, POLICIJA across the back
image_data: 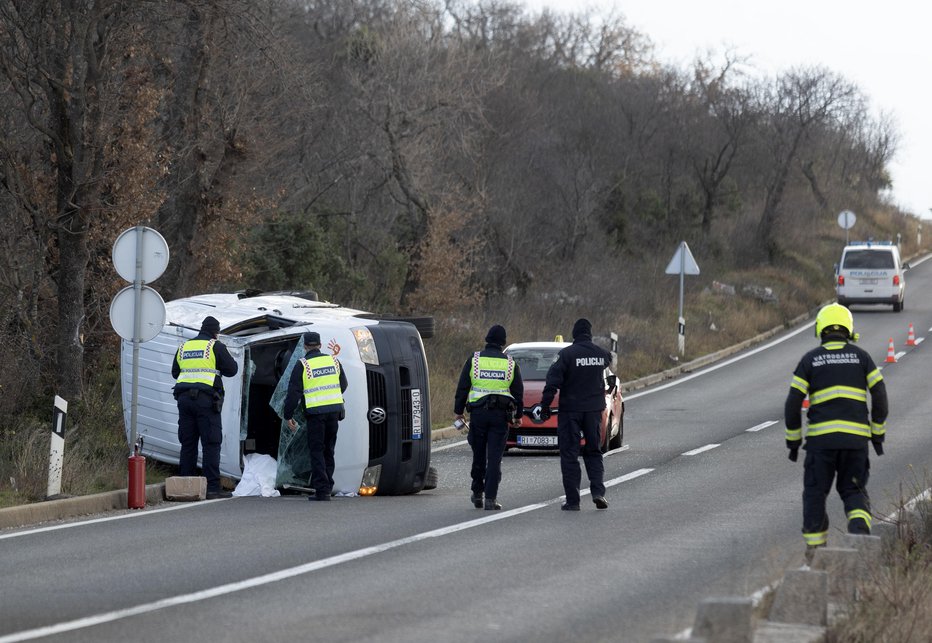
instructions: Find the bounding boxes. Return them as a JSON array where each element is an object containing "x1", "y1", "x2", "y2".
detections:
[{"x1": 537, "y1": 319, "x2": 612, "y2": 511}]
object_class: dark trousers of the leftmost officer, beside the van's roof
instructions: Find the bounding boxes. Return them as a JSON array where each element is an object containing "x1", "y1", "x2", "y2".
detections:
[{"x1": 178, "y1": 391, "x2": 223, "y2": 492}]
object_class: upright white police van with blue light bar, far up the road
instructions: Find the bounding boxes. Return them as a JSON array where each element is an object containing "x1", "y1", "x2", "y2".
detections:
[{"x1": 835, "y1": 241, "x2": 909, "y2": 312}]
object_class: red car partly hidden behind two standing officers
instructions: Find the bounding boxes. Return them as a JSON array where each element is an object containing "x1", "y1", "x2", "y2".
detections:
[{"x1": 505, "y1": 333, "x2": 625, "y2": 453}]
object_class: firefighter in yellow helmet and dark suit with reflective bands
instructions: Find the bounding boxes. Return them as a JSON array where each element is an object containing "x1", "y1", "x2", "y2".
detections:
[{"x1": 784, "y1": 304, "x2": 887, "y2": 559}]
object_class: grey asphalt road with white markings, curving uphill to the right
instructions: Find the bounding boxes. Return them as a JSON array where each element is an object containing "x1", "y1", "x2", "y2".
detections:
[{"x1": 0, "y1": 263, "x2": 932, "y2": 643}]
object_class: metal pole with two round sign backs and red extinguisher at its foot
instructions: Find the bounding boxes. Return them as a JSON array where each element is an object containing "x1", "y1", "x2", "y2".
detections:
[{"x1": 110, "y1": 226, "x2": 168, "y2": 509}]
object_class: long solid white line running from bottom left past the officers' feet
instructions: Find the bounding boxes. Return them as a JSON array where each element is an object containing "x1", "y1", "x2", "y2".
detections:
[{"x1": 0, "y1": 469, "x2": 653, "y2": 643}]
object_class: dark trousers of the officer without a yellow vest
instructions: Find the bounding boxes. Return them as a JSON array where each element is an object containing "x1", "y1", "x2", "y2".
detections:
[{"x1": 557, "y1": 411, "x2": 605, "y2": 505}]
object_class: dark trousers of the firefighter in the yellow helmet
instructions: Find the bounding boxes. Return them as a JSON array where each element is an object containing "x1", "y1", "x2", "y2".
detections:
[{"x1": 803, "y1": 447, "x2": 870, "y2": 534}]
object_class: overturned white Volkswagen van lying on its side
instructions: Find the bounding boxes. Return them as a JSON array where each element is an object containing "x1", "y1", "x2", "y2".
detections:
[{"x1": 121, "y1": 293, "x2": 436, "y2": 495}]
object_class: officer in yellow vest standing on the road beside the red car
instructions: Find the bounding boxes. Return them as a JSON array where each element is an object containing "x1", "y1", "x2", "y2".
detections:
[{"x1": 453, "y1": 324, "x2": 524, "y2": 510}]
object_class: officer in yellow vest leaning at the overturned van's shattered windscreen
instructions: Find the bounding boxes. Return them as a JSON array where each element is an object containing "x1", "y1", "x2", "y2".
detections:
[{"x1": 282, "y1": 332, "x2": 347, "y2": 501}]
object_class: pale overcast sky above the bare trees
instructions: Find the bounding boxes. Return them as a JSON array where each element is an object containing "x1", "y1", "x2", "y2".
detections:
[{"x1": 515, "y1": 0, "x2": 932, "y2": 219}]
